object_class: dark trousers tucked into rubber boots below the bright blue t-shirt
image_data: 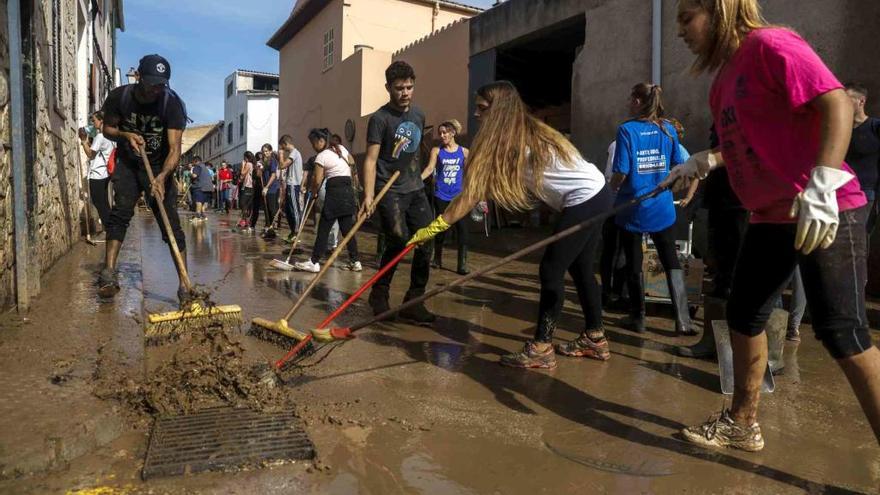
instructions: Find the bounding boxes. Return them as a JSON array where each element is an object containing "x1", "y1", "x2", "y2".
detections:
[{"x1": 620, "y1": 225, "x2": 690, "y2": 326}]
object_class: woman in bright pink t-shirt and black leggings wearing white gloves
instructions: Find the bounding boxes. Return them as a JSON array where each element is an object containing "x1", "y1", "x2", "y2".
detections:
[{"x1": 665, "y1": 0, "x2": 880, "y2": 451}]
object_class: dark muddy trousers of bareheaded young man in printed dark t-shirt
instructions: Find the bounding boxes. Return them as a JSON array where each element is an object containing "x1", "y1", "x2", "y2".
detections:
[{"x1": 373, "y1": 190, "x2": 434, "y2": 297}]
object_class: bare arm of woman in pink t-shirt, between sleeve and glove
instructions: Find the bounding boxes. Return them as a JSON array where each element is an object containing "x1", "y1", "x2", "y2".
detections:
[{"x1": 808, "y1": 89, "x2": 852, "y2": 168}]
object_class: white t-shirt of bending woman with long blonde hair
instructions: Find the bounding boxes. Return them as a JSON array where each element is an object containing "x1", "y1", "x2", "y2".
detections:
[{"x1": 526, "y1": 152, "x2": 605, "y2": 211}]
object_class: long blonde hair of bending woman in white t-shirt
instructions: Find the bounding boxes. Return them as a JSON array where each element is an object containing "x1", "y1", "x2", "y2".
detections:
[{"x1": 463, "y1": 81, "x2": 580, "y2": 211}]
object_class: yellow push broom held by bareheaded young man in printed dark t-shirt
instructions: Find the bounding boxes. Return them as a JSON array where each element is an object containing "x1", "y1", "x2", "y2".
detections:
[{"x1": 248, "y1": 171, "x2": 400, "y2": 349}]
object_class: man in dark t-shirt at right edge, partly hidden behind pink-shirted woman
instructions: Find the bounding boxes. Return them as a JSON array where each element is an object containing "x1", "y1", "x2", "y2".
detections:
[{"x1": 846, "y1": 83, "x2": 880, "y2": 234}]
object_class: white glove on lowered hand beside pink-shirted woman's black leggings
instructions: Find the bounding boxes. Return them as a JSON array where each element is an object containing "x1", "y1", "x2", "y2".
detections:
[{"x1": 788, "y1": 165, "x2": 855, "y2": 254}]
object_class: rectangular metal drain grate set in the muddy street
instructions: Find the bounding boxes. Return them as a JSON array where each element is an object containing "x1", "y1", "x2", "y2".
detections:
[{"x1": 142, "y1": 407, "x2": 315, "y2": 480}]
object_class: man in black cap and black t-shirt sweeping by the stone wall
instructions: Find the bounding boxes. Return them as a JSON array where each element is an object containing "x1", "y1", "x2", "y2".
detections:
[{"x1": 98, "y1": 55, "x2": 187, "y2": 301}]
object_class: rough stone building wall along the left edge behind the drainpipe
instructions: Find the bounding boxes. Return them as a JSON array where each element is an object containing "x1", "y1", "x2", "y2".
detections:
[{"x1": 0, "y1": 0, "x2": 82, "y2": 307}]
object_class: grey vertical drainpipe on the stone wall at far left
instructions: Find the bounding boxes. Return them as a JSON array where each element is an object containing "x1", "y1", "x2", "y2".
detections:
[{"x1": 6, "y1": 0, "x2": 30, "y2": 313}]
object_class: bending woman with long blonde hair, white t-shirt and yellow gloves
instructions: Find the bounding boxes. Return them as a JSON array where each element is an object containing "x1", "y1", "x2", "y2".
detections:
[{"x1": 409, "y1": 81, "x2": 612, "y2": 369}]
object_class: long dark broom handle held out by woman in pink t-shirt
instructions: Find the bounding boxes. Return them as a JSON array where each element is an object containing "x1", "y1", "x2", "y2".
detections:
[{"x1": 350, "y1": 187, "x2": 666, "y2": 332}]
